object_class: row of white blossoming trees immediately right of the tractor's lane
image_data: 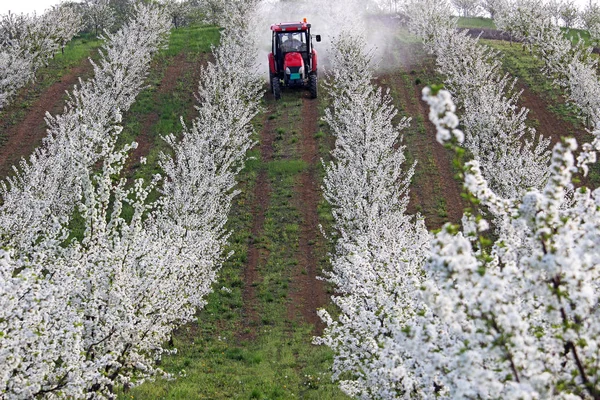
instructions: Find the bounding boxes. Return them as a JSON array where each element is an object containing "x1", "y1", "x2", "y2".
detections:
[{"x1": 316, "y1": 32, "x2": 429, "y2": 398}]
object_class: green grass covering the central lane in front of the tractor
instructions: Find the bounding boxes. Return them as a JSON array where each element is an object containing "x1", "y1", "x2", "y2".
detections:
[{"x1": 120, "y1": 83, "x2": 347, "y2": 399}]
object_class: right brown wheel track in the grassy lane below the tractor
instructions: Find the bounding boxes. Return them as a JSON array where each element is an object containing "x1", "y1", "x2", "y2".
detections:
[{"x1": 288, "y1": 96, "x2": 328, "y2": 335}]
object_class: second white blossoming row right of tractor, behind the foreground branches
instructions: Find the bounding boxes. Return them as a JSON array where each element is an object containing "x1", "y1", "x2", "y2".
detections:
[{"x1": 406, "y1": 0, "x2": 550, "y2": 198}]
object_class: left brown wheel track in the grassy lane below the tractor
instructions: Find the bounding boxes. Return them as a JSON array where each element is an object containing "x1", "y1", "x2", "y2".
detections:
[{"x1": 241, "y1": 105, "x2": 275, "y2": 340}]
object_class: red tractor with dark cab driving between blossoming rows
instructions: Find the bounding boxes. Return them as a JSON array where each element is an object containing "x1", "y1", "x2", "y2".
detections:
[{"x1": 269, "y1": 18, "x2": 321, "y2": 100}]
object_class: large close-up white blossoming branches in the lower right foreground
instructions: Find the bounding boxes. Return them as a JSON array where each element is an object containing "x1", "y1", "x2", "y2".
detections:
[{"x1": 426, "y1": 89, "x2": 600, "y2": 399}]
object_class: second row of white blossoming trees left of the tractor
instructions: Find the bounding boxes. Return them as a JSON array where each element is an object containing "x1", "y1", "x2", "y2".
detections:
[{"x1": 0, "y1": 3, "x2": 169, "y2": 252}]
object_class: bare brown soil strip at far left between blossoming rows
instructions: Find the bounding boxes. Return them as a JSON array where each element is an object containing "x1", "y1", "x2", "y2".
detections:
[{"x1": 0, "y1": 57, "x2": 93, "y2": 177}]
